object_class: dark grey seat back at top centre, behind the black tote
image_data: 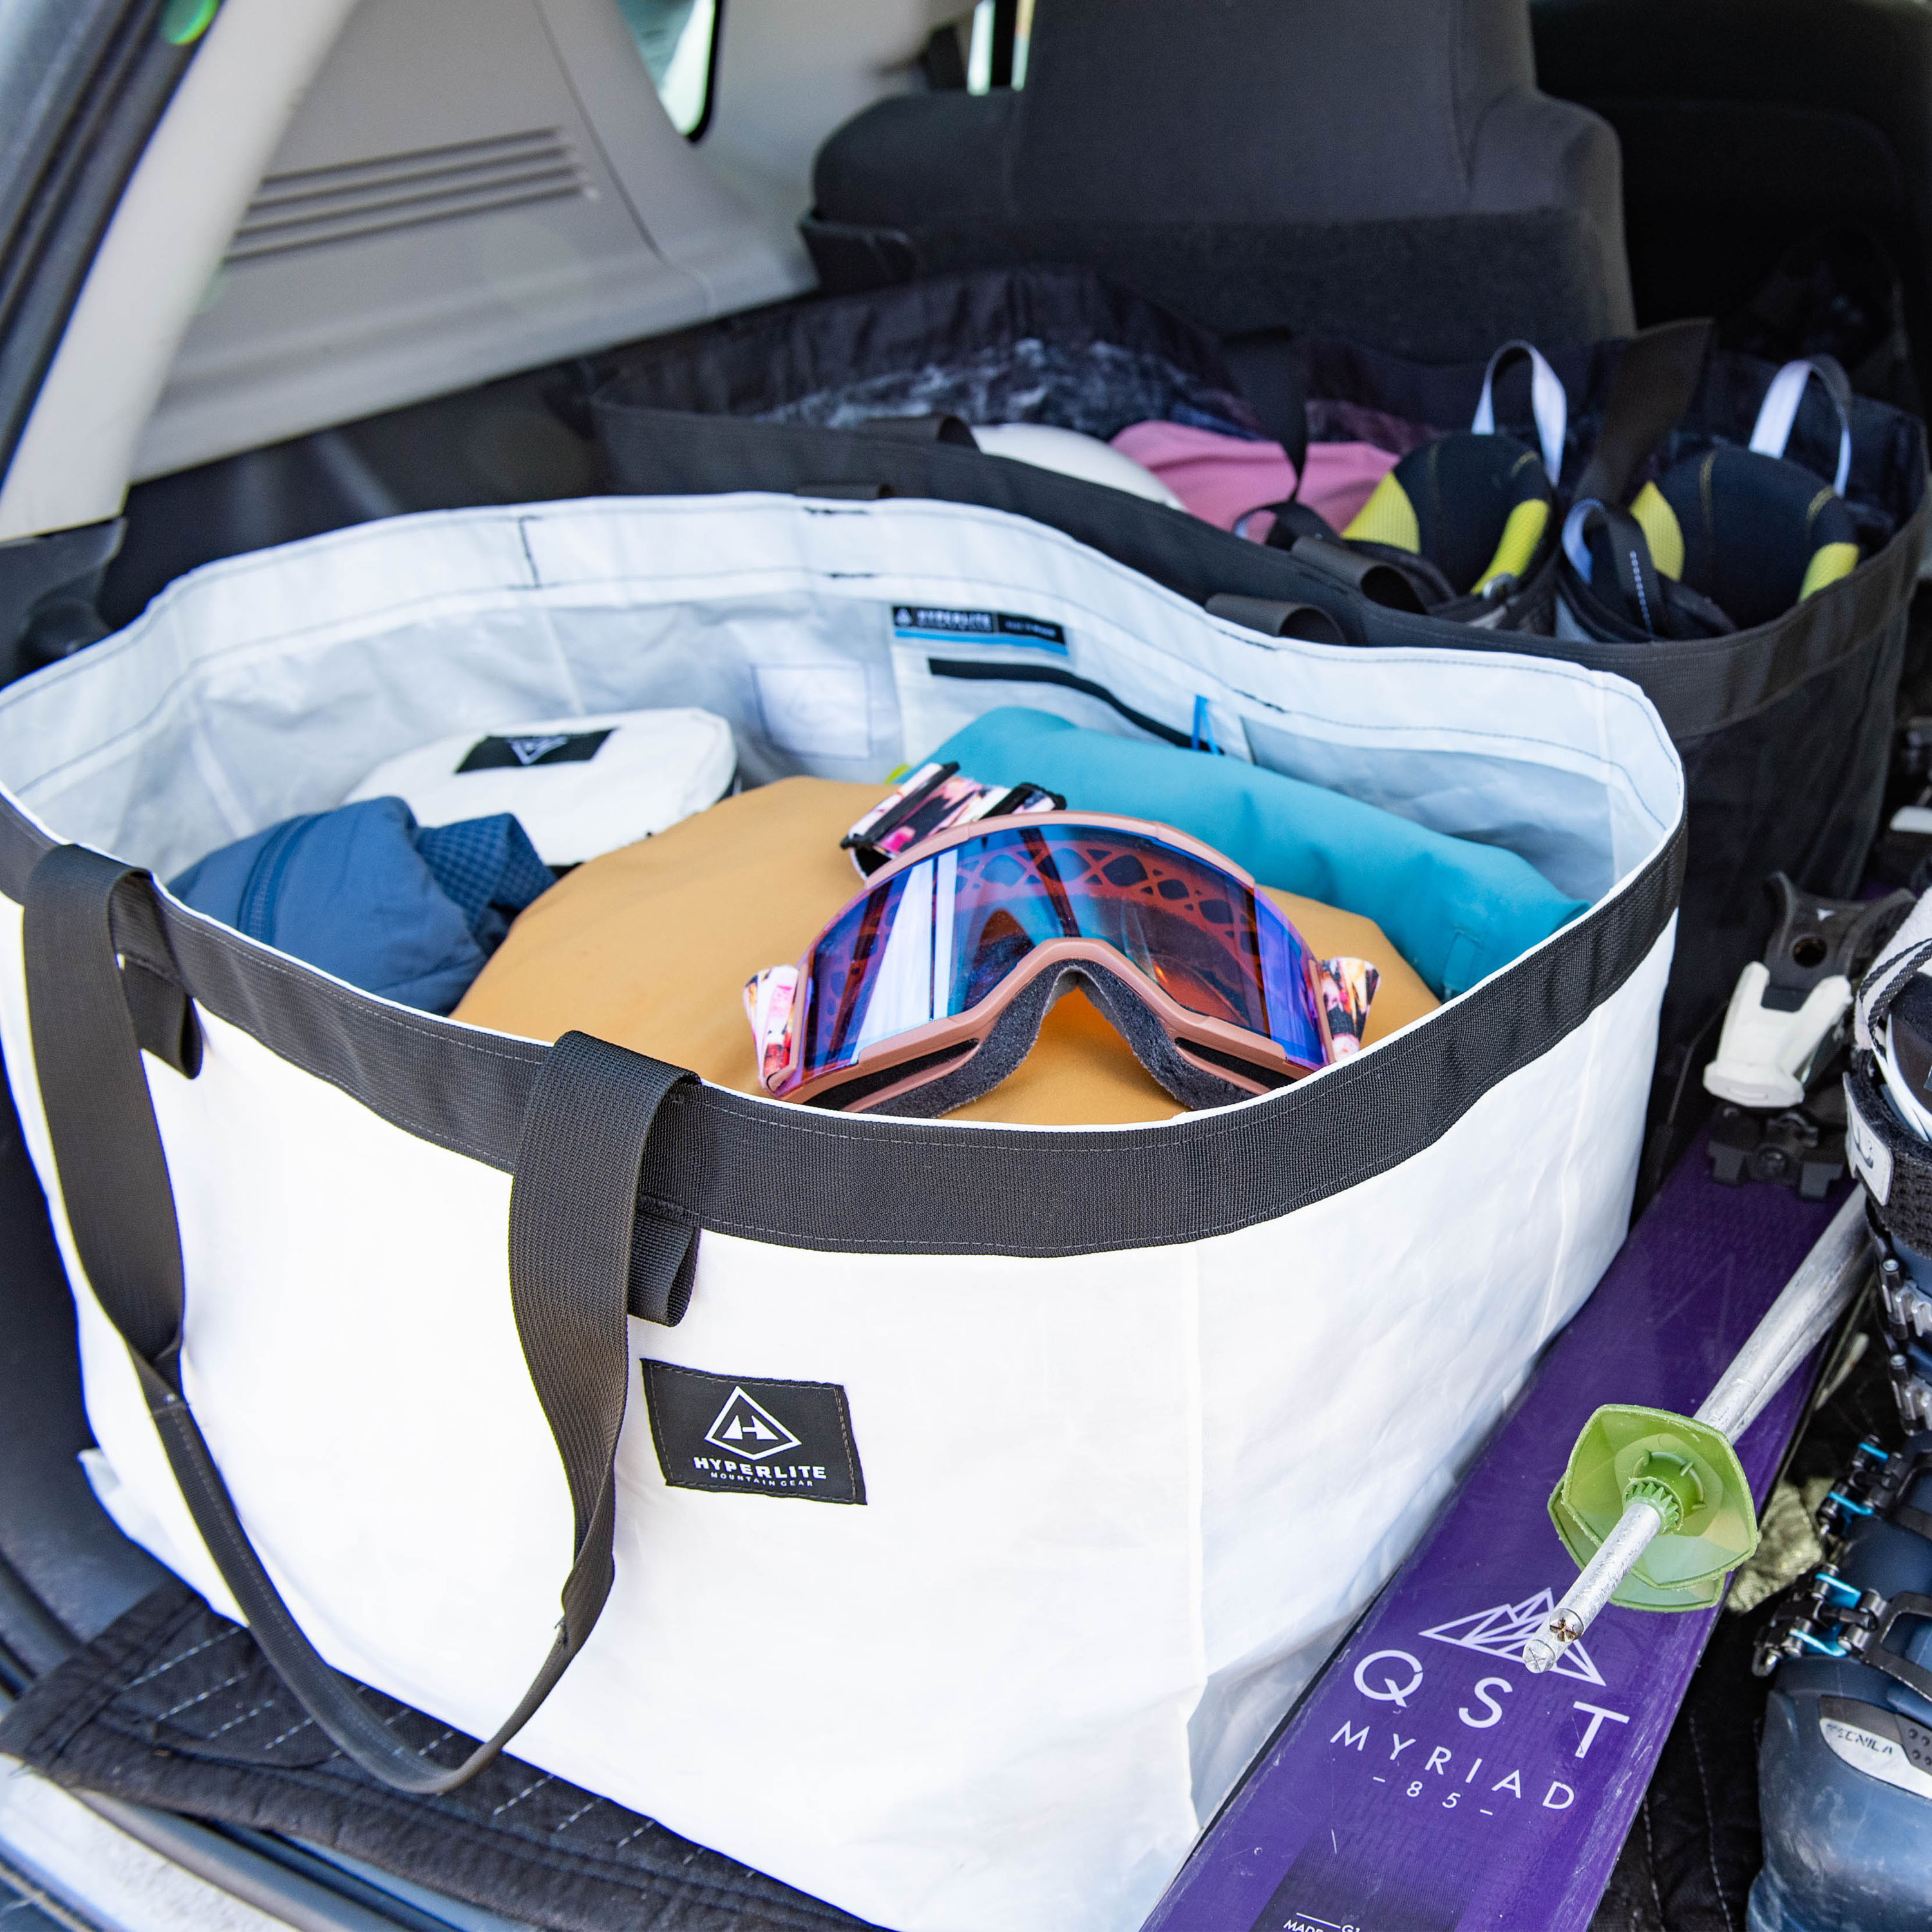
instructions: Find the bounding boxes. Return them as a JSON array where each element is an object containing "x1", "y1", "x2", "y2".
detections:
[{"x1": 806, "y1": 0, "x2": 1633, "y2": 359}]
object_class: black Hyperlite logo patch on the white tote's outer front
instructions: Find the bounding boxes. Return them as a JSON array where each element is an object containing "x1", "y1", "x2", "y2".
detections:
[{"x1": 641, "y1": 1358, "x2": 866, "y2": 1503}]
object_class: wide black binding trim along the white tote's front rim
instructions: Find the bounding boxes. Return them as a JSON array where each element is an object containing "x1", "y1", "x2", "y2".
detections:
[{"x1": 0, "y1": 800, "x2": 1685, "y2": 1258}]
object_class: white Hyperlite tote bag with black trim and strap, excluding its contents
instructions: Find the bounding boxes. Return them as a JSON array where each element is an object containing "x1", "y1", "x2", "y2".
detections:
[{"x1": 0, "y1": 497, "x2": 1683, "y2": 1932}]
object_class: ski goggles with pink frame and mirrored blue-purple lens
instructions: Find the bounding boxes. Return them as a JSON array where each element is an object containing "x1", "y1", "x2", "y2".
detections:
[{"x1": 744, "y1": 811, "x2": 1376, "y2": 1117}]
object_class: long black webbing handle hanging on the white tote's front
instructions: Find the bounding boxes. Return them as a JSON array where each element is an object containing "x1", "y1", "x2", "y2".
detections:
[{"x1": 25, "y1": 846, "x2": 696, "y2": 1797}]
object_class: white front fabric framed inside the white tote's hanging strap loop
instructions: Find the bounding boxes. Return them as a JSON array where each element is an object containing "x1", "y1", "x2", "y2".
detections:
[{"x1": 149, "y1": 1014, "x2": 570, "y2": 1737}]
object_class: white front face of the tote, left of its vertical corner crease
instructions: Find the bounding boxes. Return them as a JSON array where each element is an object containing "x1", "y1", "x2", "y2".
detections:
[{"x1": 60, "y1": 1016, "x2": 1204, "y2": 1932}]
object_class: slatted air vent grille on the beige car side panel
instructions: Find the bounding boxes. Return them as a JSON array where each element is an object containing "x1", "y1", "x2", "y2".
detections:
[{"x1": 228, "y1": 128, "x2": 593, "y2": 263}]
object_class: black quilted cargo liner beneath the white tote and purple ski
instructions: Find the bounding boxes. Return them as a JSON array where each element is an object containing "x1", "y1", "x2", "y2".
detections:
[{"x1": 0, "y1": 1578, "x2": 1777, "y2": 1932}]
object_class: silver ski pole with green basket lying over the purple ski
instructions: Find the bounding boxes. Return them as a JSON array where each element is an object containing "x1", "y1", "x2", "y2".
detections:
[{"x1": 1522, "y1": 1188, "x2": 1868, "y2": 1671}]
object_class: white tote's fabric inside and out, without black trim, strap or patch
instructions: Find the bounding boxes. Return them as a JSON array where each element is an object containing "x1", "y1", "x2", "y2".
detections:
[{"x1": 0, "y1": 497, "x2": 1683, "y2": 1932}]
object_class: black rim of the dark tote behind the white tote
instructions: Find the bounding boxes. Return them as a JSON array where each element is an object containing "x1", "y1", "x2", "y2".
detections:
[{"x1": 595, "y1": 305, "x2": 1928, "y2": 750}]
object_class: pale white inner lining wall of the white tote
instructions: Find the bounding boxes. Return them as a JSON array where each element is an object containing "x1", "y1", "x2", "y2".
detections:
[{"x1": 0, "y1": 497, "x2": 1681, "y2": 896}]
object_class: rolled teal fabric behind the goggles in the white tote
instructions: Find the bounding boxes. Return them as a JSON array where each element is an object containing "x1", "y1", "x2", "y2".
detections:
[{"x1": 931, "y1": 705, "x2": 1586, "y2": 999}]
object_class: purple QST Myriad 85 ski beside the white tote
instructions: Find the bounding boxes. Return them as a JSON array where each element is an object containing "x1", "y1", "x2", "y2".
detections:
[{"x1": 1146, "y1": 1142, "x2": 1841, "y2": 1932}]
